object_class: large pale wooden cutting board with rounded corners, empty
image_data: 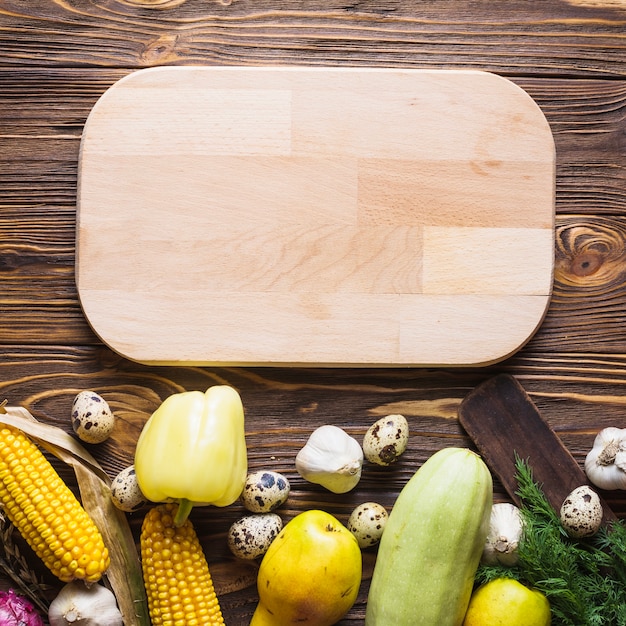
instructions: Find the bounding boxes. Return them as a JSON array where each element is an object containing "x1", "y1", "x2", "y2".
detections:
[{"x1": 77, "y1": 67, "x2": 555, "y2": 366}]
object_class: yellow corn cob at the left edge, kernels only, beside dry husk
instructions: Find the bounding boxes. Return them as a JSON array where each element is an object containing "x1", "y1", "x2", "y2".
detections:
[{"x1": 0, "y1": 425, "x2": 109, "y2": 582}]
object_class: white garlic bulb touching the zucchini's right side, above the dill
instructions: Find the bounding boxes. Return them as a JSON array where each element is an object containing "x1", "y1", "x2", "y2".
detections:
[{"x1": 482, "y1": 502, "x2": 524, "y2": 567}]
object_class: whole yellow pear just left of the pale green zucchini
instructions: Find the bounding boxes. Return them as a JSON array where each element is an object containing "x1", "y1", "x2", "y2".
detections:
[{"x1": 250, "y1": 510, "x2": 362, "y2": 626}]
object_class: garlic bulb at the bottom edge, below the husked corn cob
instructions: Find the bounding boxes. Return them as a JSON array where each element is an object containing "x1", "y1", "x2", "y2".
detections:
[{"x1": 48, "y1": 580, "x2": 124, "y2": 626}]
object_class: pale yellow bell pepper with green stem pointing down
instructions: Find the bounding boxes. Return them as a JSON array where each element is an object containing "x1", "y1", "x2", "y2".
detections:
[{"x1": 135, "y1": 385, "x2": 248, "y2": 525}]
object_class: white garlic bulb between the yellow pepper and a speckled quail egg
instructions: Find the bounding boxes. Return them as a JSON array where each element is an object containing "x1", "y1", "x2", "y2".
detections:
[{"x1": 296, "y1": 425, "x2": 363, "y2": 493}]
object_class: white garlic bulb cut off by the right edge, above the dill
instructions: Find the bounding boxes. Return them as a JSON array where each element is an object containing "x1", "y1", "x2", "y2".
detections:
[{"x1": 585, "y1": 426, "x2": 626, "y2": 490}]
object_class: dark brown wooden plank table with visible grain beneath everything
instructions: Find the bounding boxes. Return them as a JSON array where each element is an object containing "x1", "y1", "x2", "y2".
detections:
[{"x1": 0, "y1": 0, "x2": 626, "y2": 626}]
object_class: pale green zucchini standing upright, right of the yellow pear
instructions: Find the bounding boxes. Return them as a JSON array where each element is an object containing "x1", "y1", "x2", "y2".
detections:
[{"x1": 365, "y1": 448, "x2": 493, "y2": 626}]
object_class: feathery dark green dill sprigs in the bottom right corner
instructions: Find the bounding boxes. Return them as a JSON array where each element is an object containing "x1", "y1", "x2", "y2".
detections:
[{"x1": 476, "y1": 458, "x2": 626, "y2": 626}]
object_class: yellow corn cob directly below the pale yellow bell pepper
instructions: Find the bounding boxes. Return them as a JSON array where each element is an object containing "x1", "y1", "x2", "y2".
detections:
[{"x1": 140, "y1": 504, "x2": 224, "y2": 626}]
